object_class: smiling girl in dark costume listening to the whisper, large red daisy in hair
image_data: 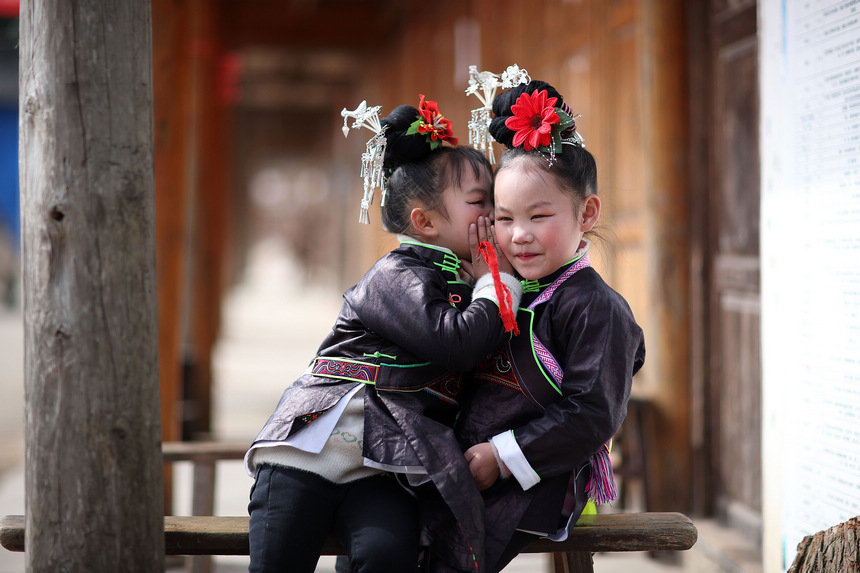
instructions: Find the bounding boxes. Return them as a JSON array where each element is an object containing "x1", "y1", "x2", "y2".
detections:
[{"x1": 430, "y1": 81, "x2": 645, "y2": 573}]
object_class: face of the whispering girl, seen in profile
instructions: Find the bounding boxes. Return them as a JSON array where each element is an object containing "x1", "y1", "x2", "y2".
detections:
[{"x1": 433, "y1": 168, "x2": 492, "y2": 260}]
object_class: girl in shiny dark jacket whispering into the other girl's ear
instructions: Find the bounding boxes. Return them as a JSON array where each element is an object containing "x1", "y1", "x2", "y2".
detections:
[{"x1": 245, "y1": 96, "x2": 520, "y2": 573}]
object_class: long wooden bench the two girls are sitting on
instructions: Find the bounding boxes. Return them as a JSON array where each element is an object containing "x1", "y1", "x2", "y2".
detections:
[{"x1": 0, "y1": 513, "x2": 698, "y2": 573}]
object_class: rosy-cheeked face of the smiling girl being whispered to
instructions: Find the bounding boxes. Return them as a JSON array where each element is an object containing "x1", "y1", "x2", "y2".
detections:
[{"x1": 495, "y1": 164, "x2": 600, "y2": 280}]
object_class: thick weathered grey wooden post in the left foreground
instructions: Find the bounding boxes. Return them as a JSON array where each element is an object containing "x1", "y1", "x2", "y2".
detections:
[{"x1": 20, "y1": 0, "x2": 164, "y2": 572}]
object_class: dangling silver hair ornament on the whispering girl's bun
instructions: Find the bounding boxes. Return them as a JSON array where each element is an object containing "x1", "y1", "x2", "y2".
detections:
[{"x1": 340, "y1": 100, "x2": 387, "y2": 225}]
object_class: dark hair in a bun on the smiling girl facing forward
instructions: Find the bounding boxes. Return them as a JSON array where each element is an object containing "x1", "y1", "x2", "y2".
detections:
[{"x1": 490, "y1": 80, "x2": 597, "y2": 206}]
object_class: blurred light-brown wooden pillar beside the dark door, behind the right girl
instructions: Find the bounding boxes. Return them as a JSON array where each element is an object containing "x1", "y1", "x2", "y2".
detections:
[{"x1": 642, "y1": 0, "x2": 691, "y2": 511}]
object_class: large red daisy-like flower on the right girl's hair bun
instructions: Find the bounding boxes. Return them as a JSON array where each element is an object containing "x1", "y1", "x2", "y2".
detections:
[{"x1": 505, "y1": 90, "x2": 576, "y2": 153}]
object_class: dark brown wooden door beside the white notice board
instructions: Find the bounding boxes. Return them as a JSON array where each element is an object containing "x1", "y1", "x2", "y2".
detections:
[{"x1": 688, "y1": 0, "x2": 761, "y2": 538}]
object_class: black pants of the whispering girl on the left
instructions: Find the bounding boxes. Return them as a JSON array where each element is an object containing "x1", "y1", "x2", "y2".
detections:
[{"x1": 248, "y1": 465, "x2": 418, "y2": 573}]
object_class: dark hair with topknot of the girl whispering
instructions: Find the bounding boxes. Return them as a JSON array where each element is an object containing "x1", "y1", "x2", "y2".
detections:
[{"x1": 380, "y1": 105, "x2": 492, "y2": 233}]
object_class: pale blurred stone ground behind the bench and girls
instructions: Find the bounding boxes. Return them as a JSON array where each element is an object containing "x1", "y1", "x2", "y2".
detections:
[{"x1": 0, "y1": 237, "x2": 681, "y2": 573}]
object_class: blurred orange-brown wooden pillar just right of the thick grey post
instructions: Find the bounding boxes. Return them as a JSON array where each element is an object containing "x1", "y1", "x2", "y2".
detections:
[{"x1": 152, "y1": 0, "x2": 196, "y2": 514}]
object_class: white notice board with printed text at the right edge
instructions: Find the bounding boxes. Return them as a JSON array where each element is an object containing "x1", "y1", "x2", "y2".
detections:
[{"x1": 759, "y1": 0, "x2": 860, "y2": 572}]
